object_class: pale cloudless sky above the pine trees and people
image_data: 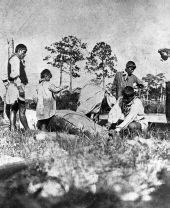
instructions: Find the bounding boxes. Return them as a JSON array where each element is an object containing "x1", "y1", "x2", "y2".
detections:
[{"x1": 0, "y1": 0, "x2": 170, "y2": 97}]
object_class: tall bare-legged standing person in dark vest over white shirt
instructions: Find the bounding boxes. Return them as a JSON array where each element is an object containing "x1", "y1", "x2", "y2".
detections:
[{"x1": 3, "y1": 44, "x2": 29, "y2": 131}]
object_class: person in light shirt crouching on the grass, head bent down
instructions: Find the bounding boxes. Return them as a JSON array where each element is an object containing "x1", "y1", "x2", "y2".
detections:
[{"x1": 107, "y1": 86, "x2": 148, "y2": 132}]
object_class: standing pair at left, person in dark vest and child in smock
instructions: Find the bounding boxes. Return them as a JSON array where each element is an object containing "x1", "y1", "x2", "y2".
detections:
[{"x1": 2, "y1": 44, "x2": 66, "y2": 131}]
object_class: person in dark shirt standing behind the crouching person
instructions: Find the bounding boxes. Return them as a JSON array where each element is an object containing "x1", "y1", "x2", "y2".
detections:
[{"x1": 112, "y1": 61, "x2": 144, "y2": 99}]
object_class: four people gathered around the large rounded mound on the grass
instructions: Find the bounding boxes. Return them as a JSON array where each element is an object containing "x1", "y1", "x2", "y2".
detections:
[{"x1": 3, "y1": 44, "x2": 148, "y2": 135}]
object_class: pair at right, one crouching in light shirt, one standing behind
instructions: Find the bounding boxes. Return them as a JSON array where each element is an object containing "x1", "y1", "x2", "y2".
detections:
[{"x1": 107, "y1": 61, "x2": 148, "y2": 132}]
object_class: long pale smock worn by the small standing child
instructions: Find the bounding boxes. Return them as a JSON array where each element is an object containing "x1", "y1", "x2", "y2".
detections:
[{"x1": 36, "y1": 81, "x2": 61, "y2": 120}]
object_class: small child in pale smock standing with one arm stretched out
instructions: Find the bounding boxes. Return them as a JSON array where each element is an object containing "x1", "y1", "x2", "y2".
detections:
[{"x1": 36, "y1": 69, "x2": 67, "y2": 131}]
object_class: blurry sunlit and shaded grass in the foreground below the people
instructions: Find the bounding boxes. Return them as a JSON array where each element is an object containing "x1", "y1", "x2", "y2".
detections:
[{"x1": 0, "y1": 124, "x2": 167, "y2": 208}]
